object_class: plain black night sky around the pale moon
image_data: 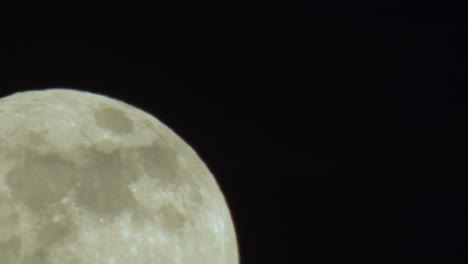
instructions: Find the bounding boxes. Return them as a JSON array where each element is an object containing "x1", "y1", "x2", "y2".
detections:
[{"x1": 0, "y1": 0, "x2": 468, "y2": 264}]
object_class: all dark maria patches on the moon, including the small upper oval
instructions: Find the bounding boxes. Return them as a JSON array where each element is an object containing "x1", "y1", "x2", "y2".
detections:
[{"x1": 0, "y1": 96, "x2": 218, "y2": 264}]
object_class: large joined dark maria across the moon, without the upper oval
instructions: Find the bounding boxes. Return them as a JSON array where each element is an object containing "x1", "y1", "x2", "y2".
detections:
[{"x1": 0, "y1": 136, "x2": 201, "y2": 263}]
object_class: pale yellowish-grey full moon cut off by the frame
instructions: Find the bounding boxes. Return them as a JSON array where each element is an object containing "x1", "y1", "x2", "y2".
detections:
[{"x1": 0, "y1": 89, "x2": 239, "y2": 264}]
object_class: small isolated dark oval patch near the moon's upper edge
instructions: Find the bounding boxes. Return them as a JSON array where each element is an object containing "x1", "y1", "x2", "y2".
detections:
[{"x1": 94, "y1": 108, "x2": 133, "y2": 133}]
